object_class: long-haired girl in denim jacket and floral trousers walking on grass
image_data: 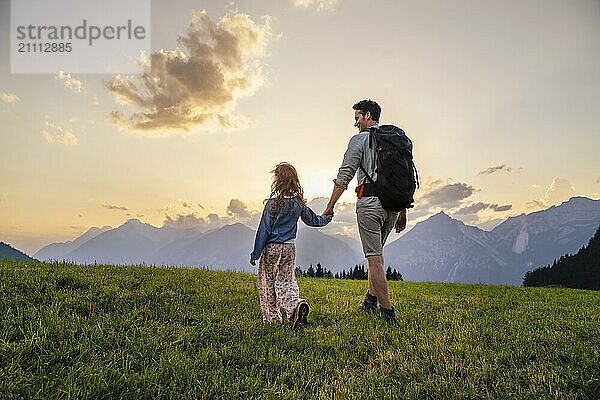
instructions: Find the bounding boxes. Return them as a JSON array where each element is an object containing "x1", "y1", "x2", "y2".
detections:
[{"x1": 250, "y1": 162, "x2": 332, "y2": 329}]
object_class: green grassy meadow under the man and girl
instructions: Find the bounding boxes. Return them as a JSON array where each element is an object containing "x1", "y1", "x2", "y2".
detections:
[{"x1": 0, "y1": 261, "x2": 600, "y2": 399}]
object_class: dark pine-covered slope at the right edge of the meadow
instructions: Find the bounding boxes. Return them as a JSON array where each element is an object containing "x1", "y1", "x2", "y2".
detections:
[{"x1": 523, "y1": 227, "x2": 600, "y2": 290}]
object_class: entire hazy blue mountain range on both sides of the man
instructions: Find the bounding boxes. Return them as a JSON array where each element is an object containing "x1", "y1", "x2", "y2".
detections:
[{"x1": 29, "y1": 197, "x2": 600, "y2": 285}]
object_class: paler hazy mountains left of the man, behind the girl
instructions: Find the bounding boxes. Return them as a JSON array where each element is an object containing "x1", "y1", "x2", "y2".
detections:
[{"x1": 35, "y1": 218, "x2": 363, "y2": 271}]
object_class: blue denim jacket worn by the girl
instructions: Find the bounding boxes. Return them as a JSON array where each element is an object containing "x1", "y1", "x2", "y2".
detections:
[{"x1": 250, "y1": 197, "x2": 327, "y2": 260}]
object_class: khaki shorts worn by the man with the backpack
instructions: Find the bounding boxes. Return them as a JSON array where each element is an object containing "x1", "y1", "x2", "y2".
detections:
[{"x1": 356, "y1": 207, "x2": 398, "y2": 257}]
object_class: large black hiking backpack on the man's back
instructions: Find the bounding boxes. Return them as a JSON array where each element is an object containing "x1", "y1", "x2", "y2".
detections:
[{"x1": 356, "y1": 125, "x2": 419, "y2": 211}]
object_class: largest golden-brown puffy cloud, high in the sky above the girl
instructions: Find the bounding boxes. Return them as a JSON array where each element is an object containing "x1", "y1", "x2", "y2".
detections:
[{"x1": 104, "y1": 10, "x2": 272, "y2": 136}]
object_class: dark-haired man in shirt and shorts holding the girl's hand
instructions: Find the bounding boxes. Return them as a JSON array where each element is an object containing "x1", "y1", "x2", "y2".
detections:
[{"x1": 323, "y1": 100, "x2": 406, "y2": 324}]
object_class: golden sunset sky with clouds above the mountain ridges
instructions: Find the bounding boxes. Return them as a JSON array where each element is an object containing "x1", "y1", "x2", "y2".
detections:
[{"x1": 0, "y1": 0, "x2": 600, "y2": 254}]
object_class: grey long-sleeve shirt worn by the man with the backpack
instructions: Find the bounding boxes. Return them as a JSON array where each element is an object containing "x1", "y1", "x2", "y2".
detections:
[{"x1": 333, "y1": 131, "x2": 382, "y2": 209}]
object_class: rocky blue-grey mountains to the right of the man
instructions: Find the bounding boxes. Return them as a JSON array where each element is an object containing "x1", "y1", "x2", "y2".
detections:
[{"x1": 384, "y1": 197, "x2": 600, "y2": 285}]
